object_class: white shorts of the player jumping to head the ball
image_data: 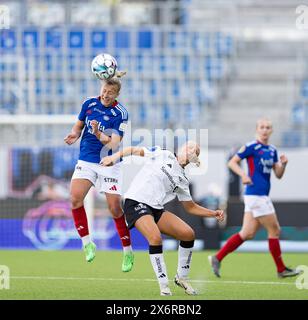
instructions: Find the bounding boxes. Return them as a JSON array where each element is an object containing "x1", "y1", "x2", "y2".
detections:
[{"x1": 72, "y1": 160, "x2": 122, "y2": 195}]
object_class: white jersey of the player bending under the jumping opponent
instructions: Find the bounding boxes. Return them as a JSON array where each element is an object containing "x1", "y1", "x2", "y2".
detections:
[{"x1": 124, "y1": 147, "x2": 192, "y2": 209}]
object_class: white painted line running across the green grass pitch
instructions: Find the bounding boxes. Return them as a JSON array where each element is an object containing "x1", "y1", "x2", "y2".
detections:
[{"x1": 10, "y1": 276, "x2": 295, "y2": 286}]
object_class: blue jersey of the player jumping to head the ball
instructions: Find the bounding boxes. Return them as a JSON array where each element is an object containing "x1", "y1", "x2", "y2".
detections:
[{"x1": 78, "y1": 97, "x2": 128, "y2": 163}]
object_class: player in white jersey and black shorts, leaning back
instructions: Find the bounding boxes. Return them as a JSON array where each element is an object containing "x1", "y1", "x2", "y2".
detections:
[{"x1": 101, "y1": 141, "x2": 224, "y2": 295}]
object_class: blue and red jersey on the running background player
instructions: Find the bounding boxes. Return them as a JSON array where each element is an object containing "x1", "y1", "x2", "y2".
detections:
[{"x1": 237, "y1": 141, "x2": 278, "y2": 196}]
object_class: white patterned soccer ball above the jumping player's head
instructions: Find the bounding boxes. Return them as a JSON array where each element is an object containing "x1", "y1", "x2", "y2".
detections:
[{"x1": 91, "y1": 53, "x2": 118, "y2": 80}]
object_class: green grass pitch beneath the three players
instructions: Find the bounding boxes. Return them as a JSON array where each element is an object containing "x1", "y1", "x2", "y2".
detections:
[{"x1": 0, "y1": 250, "x2": 308, "y2": 300}]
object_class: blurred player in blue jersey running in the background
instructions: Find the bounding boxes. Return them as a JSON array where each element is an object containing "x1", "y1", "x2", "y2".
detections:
[{"x1": 209, "y1": 119, "x2": 299, "y2": 278}]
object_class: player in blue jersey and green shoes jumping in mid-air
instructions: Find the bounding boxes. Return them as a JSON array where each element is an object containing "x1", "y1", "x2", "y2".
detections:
[{"x1": 64, "y1": 78, "x2": 134, "y2": 272}]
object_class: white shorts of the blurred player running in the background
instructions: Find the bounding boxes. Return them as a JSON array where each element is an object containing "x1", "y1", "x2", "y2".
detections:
[{"x1": 244, "y1": 195, "x2": 275, "y2": 218}]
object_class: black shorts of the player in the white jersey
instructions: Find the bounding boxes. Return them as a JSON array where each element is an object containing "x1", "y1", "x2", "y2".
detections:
[{"x1": 124, "y1": 199, "x2": 165, "y2": 229}]
